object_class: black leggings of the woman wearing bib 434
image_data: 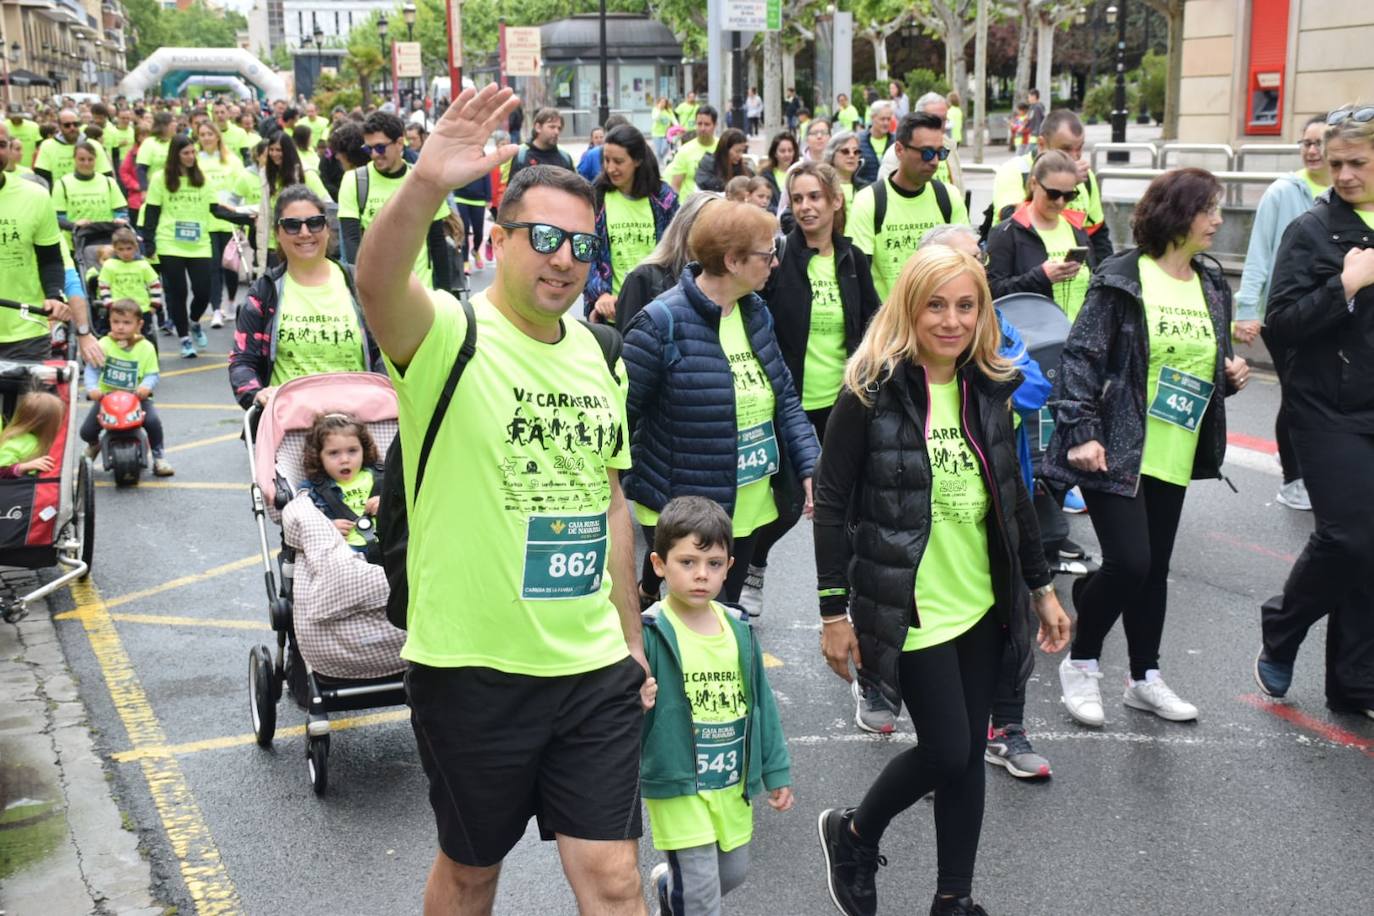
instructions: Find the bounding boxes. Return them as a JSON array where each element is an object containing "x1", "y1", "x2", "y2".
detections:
[{"x1": 1069, "y1": 477, "x2": 1189, "y2": 681}]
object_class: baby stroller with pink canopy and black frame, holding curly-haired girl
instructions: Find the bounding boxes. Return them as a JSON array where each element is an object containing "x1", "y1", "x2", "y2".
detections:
[{"x1": 243, "y1": 372, "x2": 405, "y2": 795}]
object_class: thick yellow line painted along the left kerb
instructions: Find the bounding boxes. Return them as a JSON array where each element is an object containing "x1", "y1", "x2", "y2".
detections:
[{"x1": 71, "y1": 580, "x2": 243, "y2": 916}]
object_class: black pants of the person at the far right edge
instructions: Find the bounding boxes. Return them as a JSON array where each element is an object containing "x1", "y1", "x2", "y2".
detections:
[{"x1": 1261, "y1": 430, "x2": 1374, "y2": 709}]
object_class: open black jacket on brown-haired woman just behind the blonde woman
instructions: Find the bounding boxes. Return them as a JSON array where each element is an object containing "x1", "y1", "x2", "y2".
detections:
[{"x1": 761, "y1": 229, "x2": 882, "y2": 394}]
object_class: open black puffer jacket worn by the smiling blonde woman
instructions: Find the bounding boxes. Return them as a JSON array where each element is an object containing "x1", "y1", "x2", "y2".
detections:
[{"x1": 815, "y1": 364, "x2": 1050, "y2": 703}]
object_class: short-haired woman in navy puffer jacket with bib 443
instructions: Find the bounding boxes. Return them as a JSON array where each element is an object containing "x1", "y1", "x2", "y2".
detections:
[{"x1": 625, "y1": 201, "x2": 820, "y2": 606}]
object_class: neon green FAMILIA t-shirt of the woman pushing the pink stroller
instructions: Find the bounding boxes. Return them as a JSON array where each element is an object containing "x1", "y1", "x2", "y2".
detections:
[{"x1": 272, "y1": 265, "x2": 367, "y2": 386}]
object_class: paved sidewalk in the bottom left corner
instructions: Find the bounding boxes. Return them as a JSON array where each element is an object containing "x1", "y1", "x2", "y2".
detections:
[{"x1": 0, "y1": 569, "x2": 166, "y2": 916}]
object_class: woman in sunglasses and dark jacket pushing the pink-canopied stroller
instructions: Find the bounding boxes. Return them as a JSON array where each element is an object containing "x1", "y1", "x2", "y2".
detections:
[{"x1": 229, "y1": 184, "x2": 383, "y2": 411}]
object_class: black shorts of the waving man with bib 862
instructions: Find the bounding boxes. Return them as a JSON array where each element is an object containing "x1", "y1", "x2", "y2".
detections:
[{"x1": 405, "y1": 656, "x2": 644, "y2": 867}]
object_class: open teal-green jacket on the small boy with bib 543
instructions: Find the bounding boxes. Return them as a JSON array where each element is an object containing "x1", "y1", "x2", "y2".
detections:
[{"x1": 639, "y1": 603, "x2": 791, "y2": 801}]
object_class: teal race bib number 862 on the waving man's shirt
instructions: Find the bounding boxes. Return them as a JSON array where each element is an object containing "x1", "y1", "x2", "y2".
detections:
[{"x1": 521, "y1": 512, "x2": 609, "y2": 602}]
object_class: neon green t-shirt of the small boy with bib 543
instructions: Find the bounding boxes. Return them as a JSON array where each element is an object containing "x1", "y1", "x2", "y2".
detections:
[{"x1": 644, "y1": 602, "x2": 754, "y2": 853}]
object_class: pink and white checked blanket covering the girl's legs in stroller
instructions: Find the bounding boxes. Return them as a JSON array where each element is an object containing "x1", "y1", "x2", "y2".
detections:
[{"x1": 282, "y1": 493, "x2": 405, "y2": 678}]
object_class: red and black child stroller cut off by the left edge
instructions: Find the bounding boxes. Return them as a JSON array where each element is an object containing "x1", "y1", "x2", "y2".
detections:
[{"x1": 0, "y1": 351, "x2": 95, "y2": 623}]
